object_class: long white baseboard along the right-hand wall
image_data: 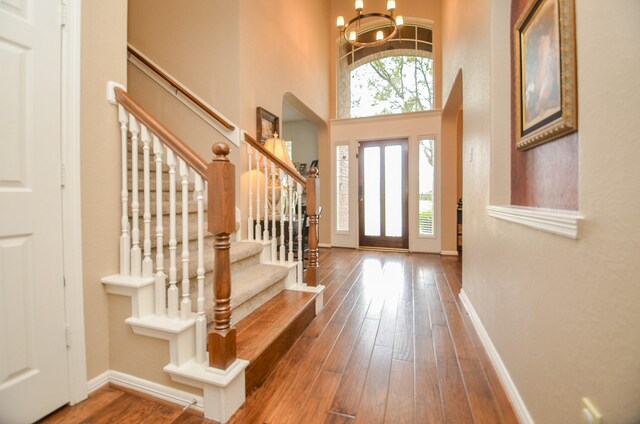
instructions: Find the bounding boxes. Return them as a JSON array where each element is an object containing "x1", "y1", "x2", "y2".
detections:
[{"x1": 460, "y1": 289, "x2": 534, "y2": 424}]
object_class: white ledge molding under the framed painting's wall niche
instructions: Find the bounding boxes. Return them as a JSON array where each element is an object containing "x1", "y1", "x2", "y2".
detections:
[{"x1": 487, "y1": 206, "x2": 583, "y2": 239}]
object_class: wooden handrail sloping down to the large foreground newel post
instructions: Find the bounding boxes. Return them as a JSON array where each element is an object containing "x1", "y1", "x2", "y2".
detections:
[{"x1": 115, "y1": 88, "x2": 208, "y2": 179}]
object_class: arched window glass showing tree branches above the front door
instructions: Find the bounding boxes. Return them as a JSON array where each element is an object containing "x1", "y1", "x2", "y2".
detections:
[{"x1": 351, "y1": 56, "x2": 434, "y2": 118}]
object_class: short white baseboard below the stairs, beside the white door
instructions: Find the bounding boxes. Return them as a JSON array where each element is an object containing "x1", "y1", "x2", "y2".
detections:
[{"x1": 87, "y1": 370, "x2": 204, "y2": 411}]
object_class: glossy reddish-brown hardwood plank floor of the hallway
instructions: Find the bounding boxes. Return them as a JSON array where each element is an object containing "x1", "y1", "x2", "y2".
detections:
[{"x1": 41, "y1": 248, "x2": 518, "y2": 424}]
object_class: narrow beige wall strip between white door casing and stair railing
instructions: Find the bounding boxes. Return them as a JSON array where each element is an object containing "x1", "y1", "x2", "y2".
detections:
[{"x1": 81, "y1": 0, "x2": 127, "y2": 379}]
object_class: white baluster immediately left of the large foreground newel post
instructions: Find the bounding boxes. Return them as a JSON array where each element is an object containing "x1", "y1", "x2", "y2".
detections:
[{"x1": 195, "y1": 174, "x2": 206, "y2": 363}]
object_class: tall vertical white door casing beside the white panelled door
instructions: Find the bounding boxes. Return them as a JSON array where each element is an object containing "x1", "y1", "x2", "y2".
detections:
[{"x1": 61, "y1": 0, "x2": 88, "y2": 405}]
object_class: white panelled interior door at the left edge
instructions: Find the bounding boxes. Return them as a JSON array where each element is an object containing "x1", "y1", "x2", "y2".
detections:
[{"x1": 0, "y1": 0, "x2": 69, "y2": 423}]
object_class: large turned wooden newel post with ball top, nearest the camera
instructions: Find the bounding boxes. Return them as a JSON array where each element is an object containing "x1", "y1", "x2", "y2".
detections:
[{"x1": 207, "y1": 143, "x2": 236, "y2": 369}]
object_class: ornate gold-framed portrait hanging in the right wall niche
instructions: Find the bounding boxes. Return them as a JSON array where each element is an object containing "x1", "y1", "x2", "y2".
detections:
[{"x1": 513, "y1": 0, "x2": 578, "y2": 150}]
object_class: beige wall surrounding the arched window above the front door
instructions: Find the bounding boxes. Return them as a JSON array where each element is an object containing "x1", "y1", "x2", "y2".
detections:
[{"x1": 325, "y1": 0, "x2": 443, "y2": 118}]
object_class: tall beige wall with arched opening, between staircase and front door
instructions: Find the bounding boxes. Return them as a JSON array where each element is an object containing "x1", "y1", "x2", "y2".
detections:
[{"x1": 239, "y1": 0, "x2": 331, "y2": 243}]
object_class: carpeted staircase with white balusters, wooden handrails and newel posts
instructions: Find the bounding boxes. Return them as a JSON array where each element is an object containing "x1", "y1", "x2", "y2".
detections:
[{"x1": 102, "y1": 81, "x2": 324, "y2": 422}]
